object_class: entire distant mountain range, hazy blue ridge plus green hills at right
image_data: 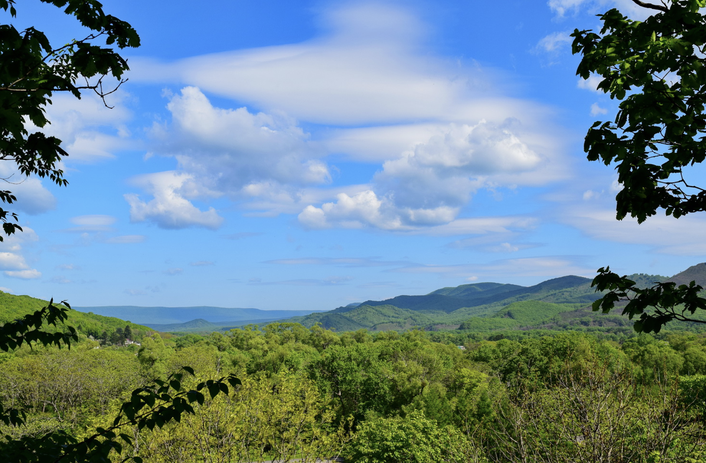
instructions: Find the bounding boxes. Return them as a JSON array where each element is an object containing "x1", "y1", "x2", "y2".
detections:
[{"x1": 75, "y1": 263, "x2": 706, "y2": 332}]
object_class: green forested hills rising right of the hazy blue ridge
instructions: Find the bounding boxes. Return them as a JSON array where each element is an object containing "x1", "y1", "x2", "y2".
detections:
[{"x1": 289, "y1": 272, "x2": 680, "y2": 331}]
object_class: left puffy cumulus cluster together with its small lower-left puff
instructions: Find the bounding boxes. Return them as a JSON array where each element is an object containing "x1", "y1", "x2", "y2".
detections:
[{"x1": 125, "y1": 87, "x2": 331, "y2": 228}]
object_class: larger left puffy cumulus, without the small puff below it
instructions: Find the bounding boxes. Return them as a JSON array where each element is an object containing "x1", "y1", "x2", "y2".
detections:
[{"x1": 160, "y1": 87, "x2": 330, "y2": 188}]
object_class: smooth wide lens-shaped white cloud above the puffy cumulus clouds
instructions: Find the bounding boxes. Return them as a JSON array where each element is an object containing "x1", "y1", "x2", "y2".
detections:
[{"x1": 131, "y1": 3, "x2": 466, "y2": 124}]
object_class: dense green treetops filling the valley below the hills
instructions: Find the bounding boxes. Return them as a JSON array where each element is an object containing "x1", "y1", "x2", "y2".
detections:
[{"x1": 0, "y1": 314, "x2": 706, "y2": 462}]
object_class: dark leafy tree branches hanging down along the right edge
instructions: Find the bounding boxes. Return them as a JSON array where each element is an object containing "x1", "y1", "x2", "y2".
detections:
[{"x1": 572, "y1": 0, "x2": 706, "y2": 332}]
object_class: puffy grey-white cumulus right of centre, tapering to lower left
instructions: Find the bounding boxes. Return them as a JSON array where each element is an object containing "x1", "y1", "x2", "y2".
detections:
[{"x1": 299, "y1": 120, "x2": 544, "y2": 230}]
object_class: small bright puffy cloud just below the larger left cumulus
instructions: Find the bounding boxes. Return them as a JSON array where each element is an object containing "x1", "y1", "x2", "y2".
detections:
[{"x1": 124, "y1": 172, "x2": 223, "y2": 229}]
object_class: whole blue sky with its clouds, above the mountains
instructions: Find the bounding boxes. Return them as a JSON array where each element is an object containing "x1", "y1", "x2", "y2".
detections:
[{"x1": 0, "y1": 0, "x2": 706, "y2": 310}]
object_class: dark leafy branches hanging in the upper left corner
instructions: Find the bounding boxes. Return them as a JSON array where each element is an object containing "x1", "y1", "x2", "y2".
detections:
[{"x1": 0, "y1": 0, "x2": 140, "y2": 240}]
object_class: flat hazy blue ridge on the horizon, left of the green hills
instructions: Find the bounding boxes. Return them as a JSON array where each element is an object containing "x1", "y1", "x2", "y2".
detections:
[{"x1": 73, "y1": 306, "x2": 314, "y2": 325}]
